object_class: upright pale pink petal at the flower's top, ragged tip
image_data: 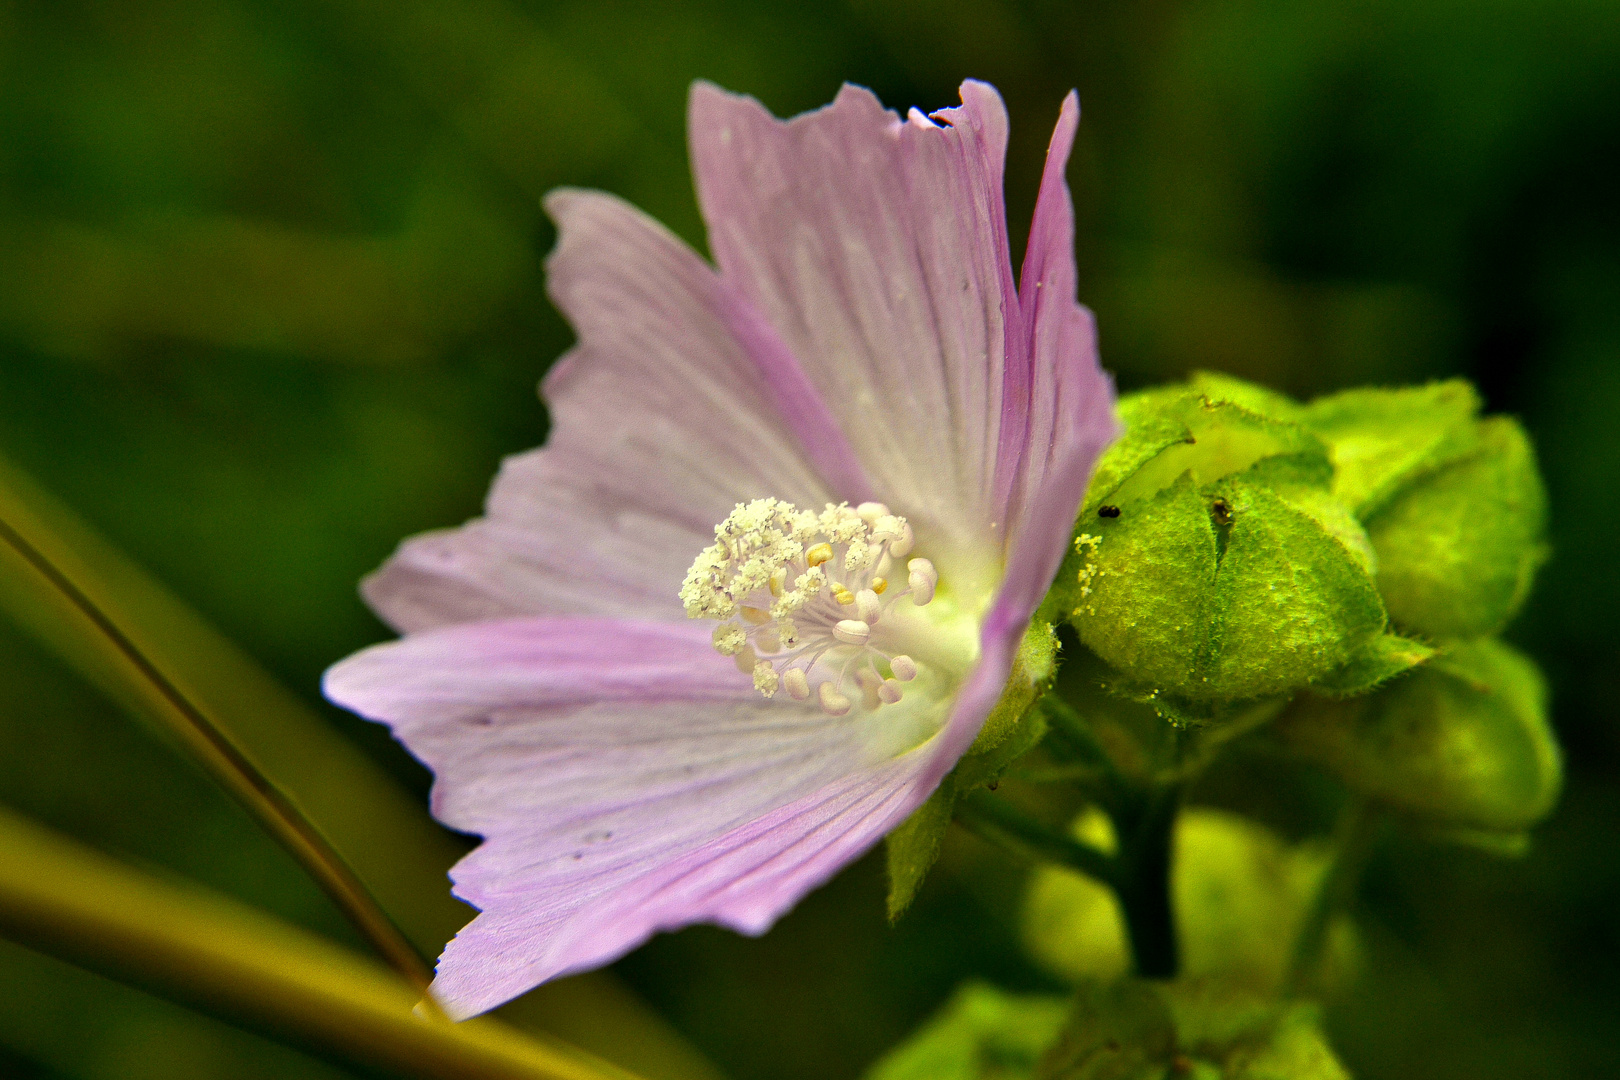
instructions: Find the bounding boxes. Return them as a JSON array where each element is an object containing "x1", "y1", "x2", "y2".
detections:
[{"x1": 689, "y1": 83, "x2": 1019, "y2": 547}]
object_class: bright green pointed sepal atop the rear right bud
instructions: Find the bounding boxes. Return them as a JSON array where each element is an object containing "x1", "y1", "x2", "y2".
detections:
[{"x1": 1298, "y1": 379, "x2": 1479, "y2": 520}]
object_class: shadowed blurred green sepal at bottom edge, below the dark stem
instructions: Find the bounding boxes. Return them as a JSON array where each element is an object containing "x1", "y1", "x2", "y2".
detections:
[{"x1": 1035, "y1": 980, "x2": 1349, "y2": 1080}]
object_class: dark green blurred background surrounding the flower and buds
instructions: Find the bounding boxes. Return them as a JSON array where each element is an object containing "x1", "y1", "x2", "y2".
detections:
[{"x1": 0, "y1": 0, "x2": 1620, "y2": 1080}]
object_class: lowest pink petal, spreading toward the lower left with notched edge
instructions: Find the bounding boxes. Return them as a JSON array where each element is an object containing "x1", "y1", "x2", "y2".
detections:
[{"x1": 326, "y1": 619, "x2": 952, "y2": 1017}]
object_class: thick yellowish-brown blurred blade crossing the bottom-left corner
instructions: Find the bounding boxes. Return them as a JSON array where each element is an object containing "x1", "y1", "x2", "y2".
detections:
[{"x1": 0, "y1": 811, "x2": 630, "y2": 1080}]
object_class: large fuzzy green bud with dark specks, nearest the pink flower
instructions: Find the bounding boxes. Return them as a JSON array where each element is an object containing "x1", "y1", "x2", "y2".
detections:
[{"x1": 1064, "y1": 389, "x2": 1385, "y2": 709}]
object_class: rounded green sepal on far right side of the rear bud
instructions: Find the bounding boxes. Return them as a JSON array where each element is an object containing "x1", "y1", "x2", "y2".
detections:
[{"x1": 1367, "y1": 416, "x2": 1547, "y2": 640}]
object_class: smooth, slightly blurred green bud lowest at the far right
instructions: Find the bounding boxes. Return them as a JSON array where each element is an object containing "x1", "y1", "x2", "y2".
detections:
[{"x1": 1277, "y1": 640, "x2": 1563, "y2": 837}]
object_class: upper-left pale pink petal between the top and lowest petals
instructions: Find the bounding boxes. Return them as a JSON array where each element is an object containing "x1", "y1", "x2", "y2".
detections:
[{"x1": 363, "y1": 191, "x2": 868, "y2": 630}]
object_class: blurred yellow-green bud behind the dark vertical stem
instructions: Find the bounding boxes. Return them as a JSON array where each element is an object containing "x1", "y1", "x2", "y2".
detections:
[{"x1": 1024, "y1": 808, "x2": 1358, "y2": 994}]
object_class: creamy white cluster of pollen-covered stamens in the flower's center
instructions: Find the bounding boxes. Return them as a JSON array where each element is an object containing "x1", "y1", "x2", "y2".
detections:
[{"x1": 680, "y1": 499, "x2": 940, "y2": 716}]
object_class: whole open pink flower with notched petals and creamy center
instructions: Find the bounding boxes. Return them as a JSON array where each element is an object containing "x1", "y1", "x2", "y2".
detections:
[{"x1": 326, "y1": 83, "x2": 1115, "y2": 1017}]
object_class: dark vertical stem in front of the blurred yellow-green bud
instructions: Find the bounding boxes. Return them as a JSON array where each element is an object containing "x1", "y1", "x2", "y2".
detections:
[{"x1": 1113, "y1": 784, "x2": 1181, "y2": 978}]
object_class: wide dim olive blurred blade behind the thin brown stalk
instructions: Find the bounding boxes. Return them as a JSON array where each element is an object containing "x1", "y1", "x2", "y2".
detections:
[{"x1": 0, "y1": 458, "x2": 716, "y2": 1080}]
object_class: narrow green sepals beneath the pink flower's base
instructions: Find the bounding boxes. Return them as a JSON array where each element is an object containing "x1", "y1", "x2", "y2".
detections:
[{"x1": 885, "y1": 620, "x2": 1058, "y2": 921}]
